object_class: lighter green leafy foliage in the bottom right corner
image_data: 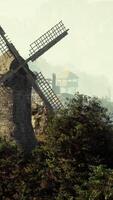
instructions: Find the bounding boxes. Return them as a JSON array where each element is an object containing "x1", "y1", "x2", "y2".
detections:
[{"x1": 77, "y1": 165, "x2": 113, "y2": 200}]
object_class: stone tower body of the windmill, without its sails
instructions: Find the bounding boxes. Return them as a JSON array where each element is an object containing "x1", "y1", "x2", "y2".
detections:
[{"x1": 0, "y1": 53, "x2": 37, "y2": 151}]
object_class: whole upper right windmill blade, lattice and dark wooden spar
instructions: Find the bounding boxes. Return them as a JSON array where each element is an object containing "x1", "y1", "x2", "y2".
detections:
[{"x1": 30, "y1": 21, "x2": 69, "y2": 61}]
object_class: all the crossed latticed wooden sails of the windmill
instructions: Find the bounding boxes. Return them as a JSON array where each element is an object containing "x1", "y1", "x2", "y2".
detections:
[{"x1": 0, "y1": 21, "x2": 68, "y2": 110}]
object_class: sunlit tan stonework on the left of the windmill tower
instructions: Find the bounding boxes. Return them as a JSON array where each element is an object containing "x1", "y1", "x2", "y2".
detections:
[{"x1": 0, "y1": 54, "x2": 15, "y2": 138}]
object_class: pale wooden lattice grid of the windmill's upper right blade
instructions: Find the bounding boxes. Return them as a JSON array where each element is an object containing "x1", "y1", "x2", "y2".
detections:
[{"x1": 30, "y1": 21, "x2": 67, "y2": 56}]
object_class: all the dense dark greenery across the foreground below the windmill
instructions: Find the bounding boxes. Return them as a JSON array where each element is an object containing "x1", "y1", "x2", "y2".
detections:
[{"x1": 0, "y1": 95, "x2": 113, "y2": 200}]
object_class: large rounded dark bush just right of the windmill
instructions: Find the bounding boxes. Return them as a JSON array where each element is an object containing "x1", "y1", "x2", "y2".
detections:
[{"x1": 47, "y1": 95, "x2": 113, "y2": 164}]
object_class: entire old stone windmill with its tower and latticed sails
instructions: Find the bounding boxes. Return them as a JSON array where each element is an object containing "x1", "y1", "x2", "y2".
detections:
[{"x1": 0, "y1": 21, "x2": 68, "y2": 151}]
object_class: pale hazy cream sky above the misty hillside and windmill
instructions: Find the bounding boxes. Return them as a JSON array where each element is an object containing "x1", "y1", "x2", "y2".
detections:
[{"x1": 0, "y1": 0, "x2": 113, "y2": 97}]
